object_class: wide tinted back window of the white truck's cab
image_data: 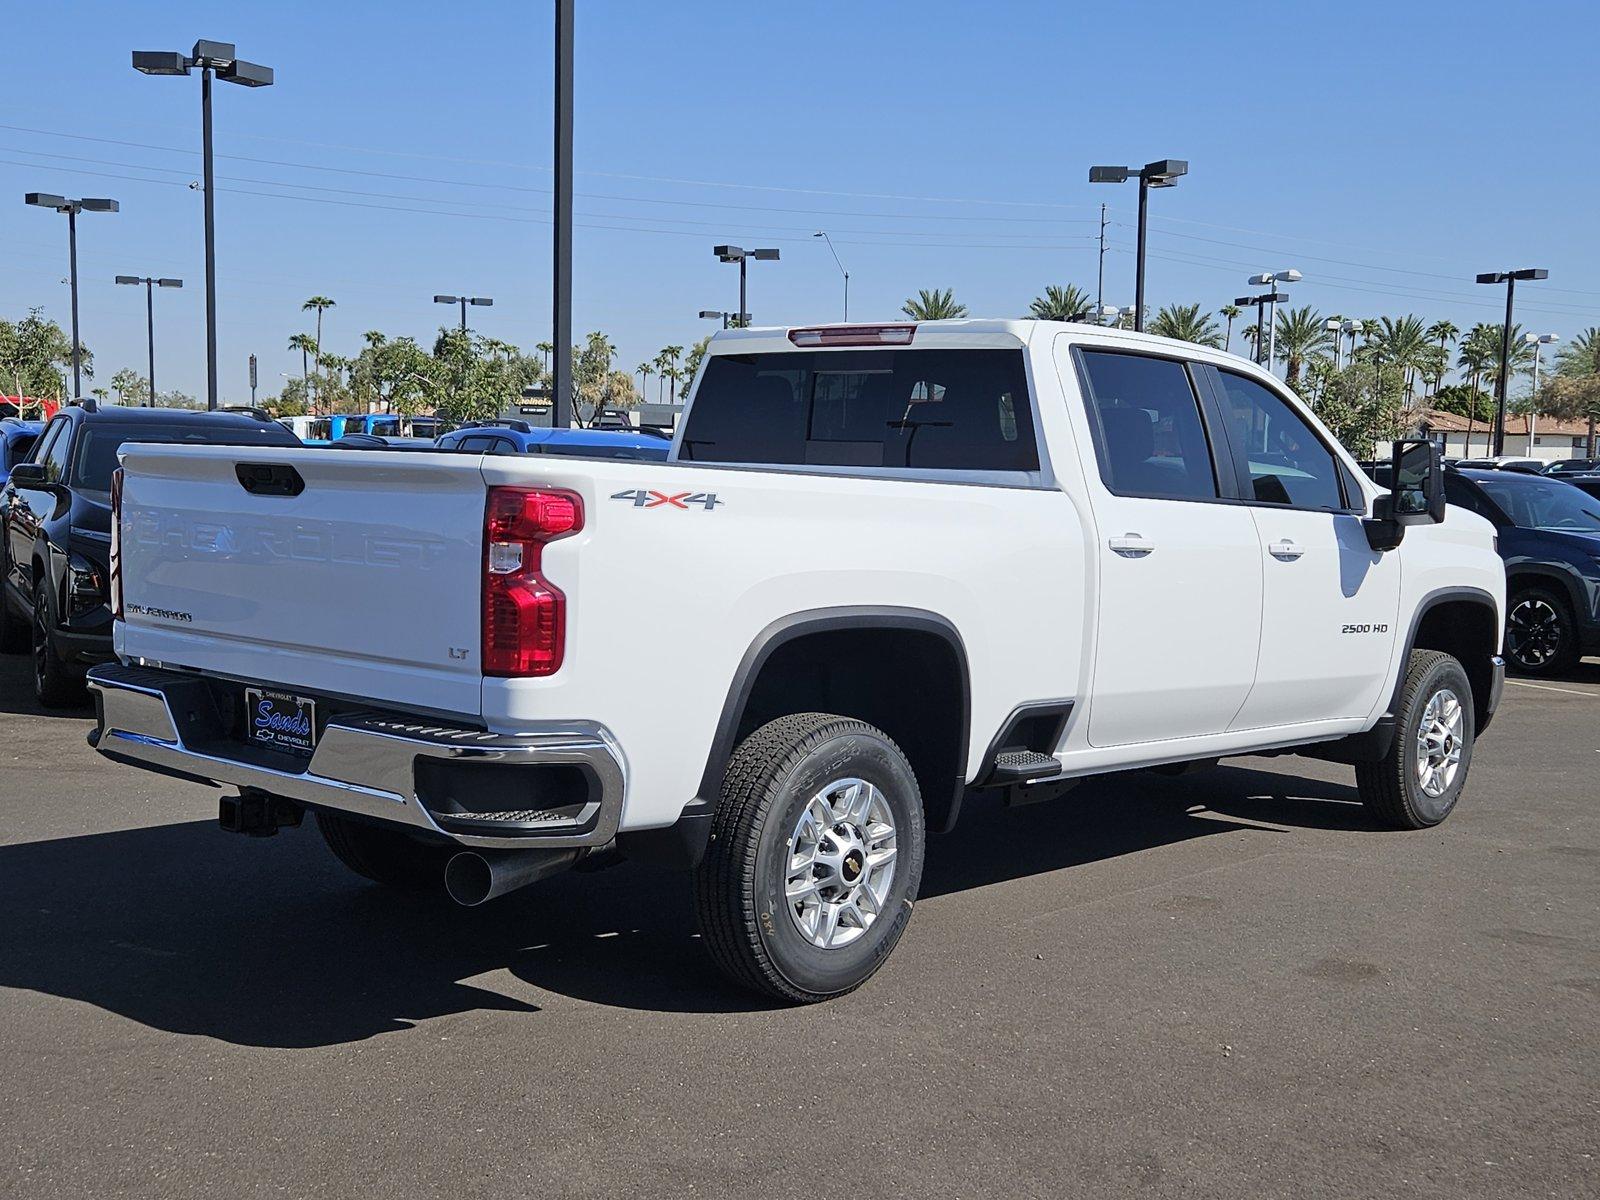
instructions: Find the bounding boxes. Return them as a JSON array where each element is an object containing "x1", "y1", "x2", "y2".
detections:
[{"x1": 680, "y1": 350, "x2": 1038, "y2": 470}]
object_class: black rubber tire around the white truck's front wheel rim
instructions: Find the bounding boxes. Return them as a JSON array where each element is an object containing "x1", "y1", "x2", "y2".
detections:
[{"x1": 1355, "y1": 650, "x2": 1477, "y2": 829}]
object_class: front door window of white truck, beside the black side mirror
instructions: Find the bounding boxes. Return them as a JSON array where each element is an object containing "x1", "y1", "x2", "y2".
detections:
[{"x1": 1216, "y1": 371, "x2": 1344, "y2": 512}]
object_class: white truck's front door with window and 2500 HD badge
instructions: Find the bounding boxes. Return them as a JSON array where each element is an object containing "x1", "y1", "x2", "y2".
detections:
[{"x1": 1203, "y1": 366, "x2": 1400, "y2": 730}]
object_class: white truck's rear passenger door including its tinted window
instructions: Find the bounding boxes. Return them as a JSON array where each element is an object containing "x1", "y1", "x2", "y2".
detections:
[{"x1": 1058, "y1": 339, "x2": 1262, "y2": 746}]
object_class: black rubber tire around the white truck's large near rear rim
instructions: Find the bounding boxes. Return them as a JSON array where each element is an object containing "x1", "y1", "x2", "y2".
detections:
[{"x1": 694, "y1": 712, "x2": 925, "y2": 1003}]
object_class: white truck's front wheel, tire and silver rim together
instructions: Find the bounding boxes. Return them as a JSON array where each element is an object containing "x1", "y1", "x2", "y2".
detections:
[{"x1": 1355, "y1": 650, "x2": 1475, "y2": 829}]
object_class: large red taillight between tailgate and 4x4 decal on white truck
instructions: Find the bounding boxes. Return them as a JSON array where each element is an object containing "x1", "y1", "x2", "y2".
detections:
[{"x1": 483, "y1": 488, "x2": 584, "y2": 675}]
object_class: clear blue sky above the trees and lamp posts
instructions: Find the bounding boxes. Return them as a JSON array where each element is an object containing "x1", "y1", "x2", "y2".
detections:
[{"x1": 0, "y1": 0, "x2": 1600, "y2": 402}]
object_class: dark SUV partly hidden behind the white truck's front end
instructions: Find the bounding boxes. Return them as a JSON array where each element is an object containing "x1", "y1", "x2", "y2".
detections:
[{"x1": 1445, "y1": 470, "x2": 1600, "y2": 675}]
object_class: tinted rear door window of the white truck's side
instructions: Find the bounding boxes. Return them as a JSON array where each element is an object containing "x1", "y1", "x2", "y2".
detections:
[{"x1": 1083, "y1": 350, "x2": 1218, "y2": 499}]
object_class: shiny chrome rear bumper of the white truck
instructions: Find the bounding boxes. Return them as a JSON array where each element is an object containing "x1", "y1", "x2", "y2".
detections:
[{"x1": 88, "y1": 662, "x2": 624, "y2": 848}]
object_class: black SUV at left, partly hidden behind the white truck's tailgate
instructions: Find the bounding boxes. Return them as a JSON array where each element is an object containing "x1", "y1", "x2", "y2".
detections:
[{"x1": 0, "y1": 405, "x2": 301, "y2": 707}]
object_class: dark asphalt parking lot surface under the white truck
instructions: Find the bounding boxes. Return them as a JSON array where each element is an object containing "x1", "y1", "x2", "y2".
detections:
[{"x1": 0, "y1": 658, "x2": 1600, "y2": 1197}]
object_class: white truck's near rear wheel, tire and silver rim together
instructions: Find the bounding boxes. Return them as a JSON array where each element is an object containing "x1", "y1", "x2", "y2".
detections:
[{"x1": 694, "y1": 712, "x2": 925, "y2": 1003}]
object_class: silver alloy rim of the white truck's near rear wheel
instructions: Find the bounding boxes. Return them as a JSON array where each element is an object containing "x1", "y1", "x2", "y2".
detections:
[{"x1": 784, "y1": 779, "x2": 896, "y2": 950}]
